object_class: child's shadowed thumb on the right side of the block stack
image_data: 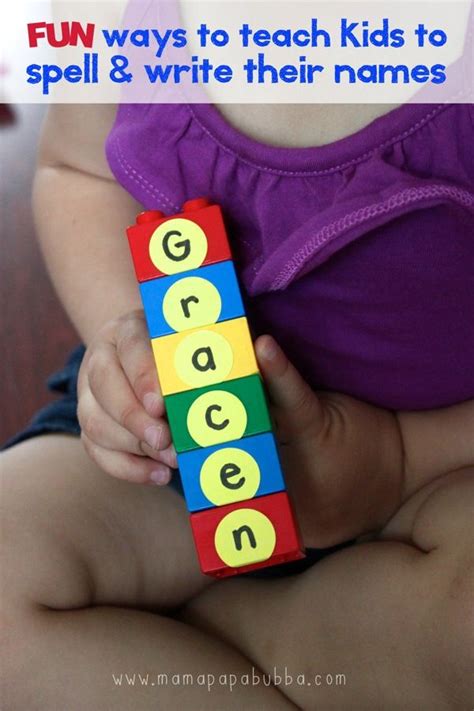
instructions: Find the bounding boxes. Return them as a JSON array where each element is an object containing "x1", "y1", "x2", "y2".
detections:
[{"x1": 255, "y1": 336, "x2": 323, "y2": 434}]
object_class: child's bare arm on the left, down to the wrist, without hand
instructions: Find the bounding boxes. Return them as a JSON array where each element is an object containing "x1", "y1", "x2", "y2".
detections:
[{"x1": 34, "y1": 105, "x2": 142, "y2": 343}]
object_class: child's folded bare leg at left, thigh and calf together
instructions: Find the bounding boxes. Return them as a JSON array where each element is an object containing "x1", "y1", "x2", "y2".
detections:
[{"x1": 1, "y1": 435, "x2": 291, "y2": 711}]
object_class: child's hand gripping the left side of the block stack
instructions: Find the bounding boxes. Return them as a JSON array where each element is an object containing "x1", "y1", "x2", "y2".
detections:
[{"x1": 78, "y1": 311, "x2": 176, "y2": 484}]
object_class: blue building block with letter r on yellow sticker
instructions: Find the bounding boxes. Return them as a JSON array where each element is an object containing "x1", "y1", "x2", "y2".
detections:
[{"x1": 139, "y1": 261, "x2": 245, "y2": 338}]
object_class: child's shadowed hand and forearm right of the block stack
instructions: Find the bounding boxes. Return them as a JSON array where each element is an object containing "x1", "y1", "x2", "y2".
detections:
[{"x1": 256, "y1": 336, "x2": 474, "y2": 547}]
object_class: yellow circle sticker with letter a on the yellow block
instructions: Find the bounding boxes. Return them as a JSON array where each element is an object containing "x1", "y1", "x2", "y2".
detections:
[{"x1": 174, "y1": 331, "x2": 234, "y2": 388}]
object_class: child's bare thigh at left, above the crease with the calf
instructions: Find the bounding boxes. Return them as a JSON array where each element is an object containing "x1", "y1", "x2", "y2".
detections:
[{"x1": 1, "y1": 435, "x2": 209, "y2": 611}]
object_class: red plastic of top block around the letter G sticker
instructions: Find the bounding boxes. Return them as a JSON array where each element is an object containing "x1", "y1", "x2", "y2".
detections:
[{"x1": 127, "y1": 198, "x2": 232, "y2": 282}]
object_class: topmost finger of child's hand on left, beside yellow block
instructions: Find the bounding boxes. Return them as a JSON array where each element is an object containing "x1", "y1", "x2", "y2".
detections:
[{"x1": 116, "y1": 316, "x2": 165, "y2": 417}]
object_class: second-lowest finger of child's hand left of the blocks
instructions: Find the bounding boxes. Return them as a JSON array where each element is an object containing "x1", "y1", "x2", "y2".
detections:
[{"x1": 77, "y1": 388, "x2": 167, "y2": 463}]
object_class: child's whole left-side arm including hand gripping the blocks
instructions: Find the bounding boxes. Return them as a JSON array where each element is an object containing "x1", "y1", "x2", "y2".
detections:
[{"x1": 34, "y1": 106, "x2": 175, "y2": 483}]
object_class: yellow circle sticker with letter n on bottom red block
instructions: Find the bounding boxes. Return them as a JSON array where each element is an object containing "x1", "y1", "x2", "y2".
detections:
[{"x1": 214, "y1": 509, "x2": 276, "y2": 568}]
